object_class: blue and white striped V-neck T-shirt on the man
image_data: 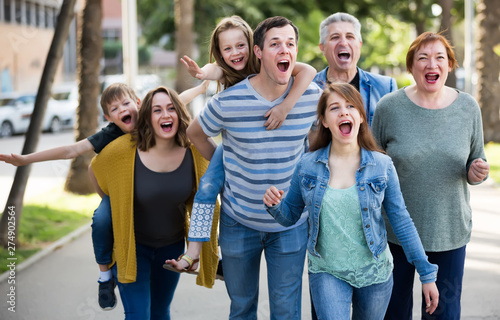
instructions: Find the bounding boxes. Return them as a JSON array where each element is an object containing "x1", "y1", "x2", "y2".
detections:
[{"x1": 198, "y1": 78, "x2": 322, "y2": 232}]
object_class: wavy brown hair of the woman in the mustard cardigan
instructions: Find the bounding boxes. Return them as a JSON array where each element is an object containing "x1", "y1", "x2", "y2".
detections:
[{"x1": 132, "y1": 86, "x2": 191, "y2": 151}]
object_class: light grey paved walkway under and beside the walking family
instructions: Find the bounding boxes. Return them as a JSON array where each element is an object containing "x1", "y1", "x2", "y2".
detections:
[{"x1": 0, "y1": 180, "x2": 500, "y2": 320}]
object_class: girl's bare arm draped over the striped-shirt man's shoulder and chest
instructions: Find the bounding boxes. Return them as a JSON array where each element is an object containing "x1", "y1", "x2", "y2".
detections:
[{"x1": 264, "y1": 62, "x2": 316, "y2": 130}]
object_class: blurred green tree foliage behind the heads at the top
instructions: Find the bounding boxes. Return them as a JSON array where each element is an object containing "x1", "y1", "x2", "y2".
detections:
[{"x1": 138, "y1": 0, "x2": 464, "y2": 73}]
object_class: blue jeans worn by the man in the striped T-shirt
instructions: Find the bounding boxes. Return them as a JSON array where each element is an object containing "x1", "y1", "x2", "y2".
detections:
[{"x1": 219, "y1": 212, "x2": 307, "y2": 320}]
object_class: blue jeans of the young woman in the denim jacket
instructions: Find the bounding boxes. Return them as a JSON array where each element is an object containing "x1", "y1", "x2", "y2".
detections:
[{"x1": 309, "y1": 272, "x2": 392, "y2": 320}]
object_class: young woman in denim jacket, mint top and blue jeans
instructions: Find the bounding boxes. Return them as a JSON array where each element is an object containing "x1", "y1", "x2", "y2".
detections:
[{"x1": 264, "y1": 83, "x2": 439, "y2": 319}]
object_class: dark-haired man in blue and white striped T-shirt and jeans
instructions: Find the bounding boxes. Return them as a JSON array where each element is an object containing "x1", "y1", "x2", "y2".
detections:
[{"x1": 188, "y1": 17, "x2": 321, "y2": 319}]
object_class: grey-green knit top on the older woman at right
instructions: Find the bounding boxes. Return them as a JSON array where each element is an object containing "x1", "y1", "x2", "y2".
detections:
[{"x1": 372, "y1": 88, "x2": 486, "y2": 252}]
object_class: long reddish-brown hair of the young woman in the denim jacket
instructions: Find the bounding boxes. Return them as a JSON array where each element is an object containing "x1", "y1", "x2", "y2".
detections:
[{"x1": 309, "y1": 83, "x2": 385, "y2": 153}]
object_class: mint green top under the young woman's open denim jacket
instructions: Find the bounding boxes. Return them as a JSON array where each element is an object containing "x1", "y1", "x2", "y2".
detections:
[{"x1": 308, "y1": 185, "x2": 393, "y2": 288}]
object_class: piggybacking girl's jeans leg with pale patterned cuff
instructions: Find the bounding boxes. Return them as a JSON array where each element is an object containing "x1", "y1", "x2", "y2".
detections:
[{"x1": 188, "y1": 144, "x2": 225, "y2": 242}]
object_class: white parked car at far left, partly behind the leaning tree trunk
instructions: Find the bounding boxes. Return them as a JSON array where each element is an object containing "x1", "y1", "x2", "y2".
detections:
[{"x1": 0, "y1": 93, "x2": 75, "y2": 137}]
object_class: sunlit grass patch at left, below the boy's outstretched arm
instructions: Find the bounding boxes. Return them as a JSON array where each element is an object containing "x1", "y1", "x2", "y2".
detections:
[{"x1": 0, "y1": 188, "x2": 101, "y2": 273}]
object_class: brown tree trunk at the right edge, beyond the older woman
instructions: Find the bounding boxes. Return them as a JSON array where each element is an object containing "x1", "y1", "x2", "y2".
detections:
[{"x1": 477, "y1": 0, "x2": 500, "y2": 142}]
